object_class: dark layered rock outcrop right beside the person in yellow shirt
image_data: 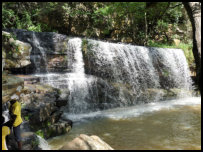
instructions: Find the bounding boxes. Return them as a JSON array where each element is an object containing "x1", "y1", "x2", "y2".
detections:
[{"x1": 20, "y1": 81, "x2": 72, "y2": 139}]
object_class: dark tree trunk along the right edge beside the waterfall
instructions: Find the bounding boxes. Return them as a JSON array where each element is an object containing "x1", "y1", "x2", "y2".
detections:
[{"x1": 183, "y1": 2, "x2": 201, "y2": 91}]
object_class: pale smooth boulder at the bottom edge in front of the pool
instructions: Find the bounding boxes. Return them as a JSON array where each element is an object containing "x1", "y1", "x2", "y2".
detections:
[{"x1": 60, "y1": 134, "x2": 113, "y2": 150}]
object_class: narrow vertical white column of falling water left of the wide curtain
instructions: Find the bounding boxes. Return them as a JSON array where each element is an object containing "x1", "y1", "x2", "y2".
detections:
[{"x1": 67, "y1": 38, "x2": 93, "y2": 113}]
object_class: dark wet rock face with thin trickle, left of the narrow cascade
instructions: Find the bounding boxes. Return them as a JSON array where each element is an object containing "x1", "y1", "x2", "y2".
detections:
[{"x1": 3, "y1": 29, "x2": 73, "y2": 74}]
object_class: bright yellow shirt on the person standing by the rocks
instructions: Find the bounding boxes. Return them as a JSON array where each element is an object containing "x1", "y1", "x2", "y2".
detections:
[{"x1": 11, "y1": 101, "x2": 23, "y2": 127}]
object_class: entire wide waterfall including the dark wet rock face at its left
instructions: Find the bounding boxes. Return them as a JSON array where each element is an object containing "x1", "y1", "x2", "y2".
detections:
[{"x1": 5, "y1": 31, "x2": 193, "y2": 114}]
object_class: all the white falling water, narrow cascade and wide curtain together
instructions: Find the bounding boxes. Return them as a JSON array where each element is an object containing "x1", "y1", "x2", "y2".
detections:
[{"x1": 33, "y1": 38, "x2": 192, "y2": 115}]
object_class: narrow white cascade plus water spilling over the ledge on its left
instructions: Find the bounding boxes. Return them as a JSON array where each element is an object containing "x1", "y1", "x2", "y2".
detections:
[{"x1": 36, "y1": 38, "x2": 93, "y2": 113}]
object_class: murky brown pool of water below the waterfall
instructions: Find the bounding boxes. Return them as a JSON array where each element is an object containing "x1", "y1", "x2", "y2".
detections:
[{"x1": 48, "y1": 98, "x2": 201, "y2": 150}]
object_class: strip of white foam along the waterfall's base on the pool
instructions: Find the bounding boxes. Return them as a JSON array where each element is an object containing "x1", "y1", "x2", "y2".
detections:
[{"x1": 63, "y1": 97, "x2": 201, "y2": 122}]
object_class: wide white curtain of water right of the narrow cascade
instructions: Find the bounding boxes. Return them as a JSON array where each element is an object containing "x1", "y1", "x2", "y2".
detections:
[{"x1": 86, "y1": 40, "x2": 191, "y2": 93}]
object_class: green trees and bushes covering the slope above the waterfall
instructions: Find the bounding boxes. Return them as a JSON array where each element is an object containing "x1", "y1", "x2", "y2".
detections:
[{"x1": 2, "y1": 2, "x2": 191, "y2": 59}]
